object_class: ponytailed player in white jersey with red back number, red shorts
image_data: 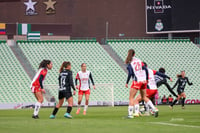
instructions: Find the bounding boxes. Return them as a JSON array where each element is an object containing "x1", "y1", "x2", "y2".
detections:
[{"x1": 125, "y1": 49, "x2": 158, "y2": 118}]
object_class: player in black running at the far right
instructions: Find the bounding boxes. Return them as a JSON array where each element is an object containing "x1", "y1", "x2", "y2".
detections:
[{"x1": 169, "y1": 71, "x2": 193, "y2": 109}]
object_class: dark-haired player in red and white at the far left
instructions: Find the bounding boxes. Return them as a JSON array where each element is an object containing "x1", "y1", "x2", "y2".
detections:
[{"x1": 31, "y1": 60, "x2": 53, "y2": 119}]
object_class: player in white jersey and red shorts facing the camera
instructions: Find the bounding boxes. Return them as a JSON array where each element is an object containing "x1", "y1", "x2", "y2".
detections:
[{"x1": 75, "y1": 63, "x2": 95, "y2": 115}]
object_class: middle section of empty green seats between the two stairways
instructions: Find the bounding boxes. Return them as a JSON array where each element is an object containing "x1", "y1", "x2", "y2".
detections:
[{"x1": 17, "y1": 40, "x2": 128, "y2": 101}]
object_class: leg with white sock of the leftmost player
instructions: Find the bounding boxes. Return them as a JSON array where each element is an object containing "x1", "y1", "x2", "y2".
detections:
[{"x1": 32, "y1": 91, "x2": 43, "y2": 119}]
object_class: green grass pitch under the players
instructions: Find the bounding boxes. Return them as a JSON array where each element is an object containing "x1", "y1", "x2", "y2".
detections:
[{"x1": 0, "y1": 105, "x2": 200, "y2": 133}]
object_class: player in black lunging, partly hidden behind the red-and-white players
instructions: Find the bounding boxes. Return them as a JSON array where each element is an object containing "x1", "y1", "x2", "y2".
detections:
[{"x1": 155, "y1": 67, "x2": 178, "y2": 97}]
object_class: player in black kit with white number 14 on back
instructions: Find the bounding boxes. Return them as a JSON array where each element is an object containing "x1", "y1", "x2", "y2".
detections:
[{"x1": 50, "y1": 62, "x2": 76, "y2": 119}]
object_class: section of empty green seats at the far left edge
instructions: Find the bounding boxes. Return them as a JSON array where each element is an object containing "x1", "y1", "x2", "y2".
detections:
[{"x1": 0, "y1": 41, "x2": 35, "y2": 103}]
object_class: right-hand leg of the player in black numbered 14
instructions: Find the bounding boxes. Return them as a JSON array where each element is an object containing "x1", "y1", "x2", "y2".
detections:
[{"x1": 64, "y1": 93, "x2": 73, "y2": 119}]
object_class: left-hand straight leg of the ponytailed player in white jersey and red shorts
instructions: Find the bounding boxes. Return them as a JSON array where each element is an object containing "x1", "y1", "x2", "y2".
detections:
[{"x1": 128, "y1": 88, "x2": 137, "y2": 118}]
